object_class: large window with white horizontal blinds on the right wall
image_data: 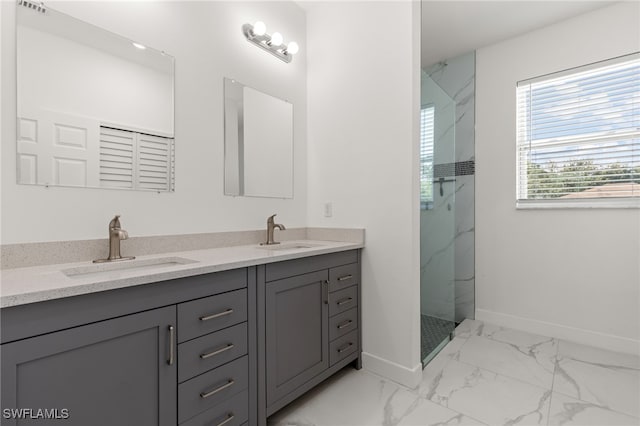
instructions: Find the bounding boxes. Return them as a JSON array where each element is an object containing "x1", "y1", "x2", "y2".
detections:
[{"x1": 517, "y1": 53, "x2": 640, "y2": 207}]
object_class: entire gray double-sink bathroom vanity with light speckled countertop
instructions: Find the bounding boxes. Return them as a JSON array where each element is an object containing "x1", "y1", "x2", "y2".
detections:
[{"x1": 0, "y1": 242, "x2": 362, "y2": 426}]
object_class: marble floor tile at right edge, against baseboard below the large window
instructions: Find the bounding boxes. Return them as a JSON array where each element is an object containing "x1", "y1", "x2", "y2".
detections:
[{"x1": 553, "y1": 341, "x2": 640, "y2": 417}]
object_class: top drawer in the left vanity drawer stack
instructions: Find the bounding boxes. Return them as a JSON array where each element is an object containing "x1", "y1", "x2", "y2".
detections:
[{"x1": 178, "y1": 289, "x2": 247, "y2": 343}]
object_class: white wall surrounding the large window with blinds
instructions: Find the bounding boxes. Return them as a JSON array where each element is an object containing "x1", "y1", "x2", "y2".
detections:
[{"x1": 476, "y1": 2, "x2": 640, "y2": 352}]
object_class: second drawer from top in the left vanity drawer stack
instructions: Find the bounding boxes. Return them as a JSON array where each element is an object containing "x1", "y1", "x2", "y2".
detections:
[{"x1": 178, "y1": 322, "x2": 247, "y2": 382}]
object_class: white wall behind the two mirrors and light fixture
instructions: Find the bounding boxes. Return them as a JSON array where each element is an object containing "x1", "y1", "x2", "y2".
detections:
[{"x1": 0, "y1": 1, "x2": 307, "y2": 244}]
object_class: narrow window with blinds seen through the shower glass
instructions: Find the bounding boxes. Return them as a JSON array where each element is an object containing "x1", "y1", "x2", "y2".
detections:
[{"x1": 420, "y1": 105, "x2": 435, "y2": 210}]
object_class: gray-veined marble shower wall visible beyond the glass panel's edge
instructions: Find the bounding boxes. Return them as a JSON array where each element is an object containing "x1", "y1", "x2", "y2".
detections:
[{"x1": 425, "y1": 52, "x2": 476, "y2": 322}]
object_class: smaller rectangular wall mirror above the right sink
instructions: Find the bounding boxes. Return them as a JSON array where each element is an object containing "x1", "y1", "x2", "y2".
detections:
[{"x1": 224, "y1": 78, "x2": 293, "y2": 198}]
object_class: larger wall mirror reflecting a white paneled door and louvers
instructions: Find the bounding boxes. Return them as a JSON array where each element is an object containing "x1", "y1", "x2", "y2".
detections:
[{"x1": 16, "y1": 1, "x2": 174, "y2": 191}]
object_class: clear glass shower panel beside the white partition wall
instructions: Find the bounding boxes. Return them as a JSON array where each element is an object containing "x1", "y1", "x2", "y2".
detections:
[{"x1": 420, "y1": 71, "x2": 456, "y2": 365}]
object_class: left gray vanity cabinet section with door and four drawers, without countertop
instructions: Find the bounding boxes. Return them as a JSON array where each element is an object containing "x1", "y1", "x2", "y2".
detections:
[{"x1": 0, "y1": 267, "x2": 252, "y2": 426}]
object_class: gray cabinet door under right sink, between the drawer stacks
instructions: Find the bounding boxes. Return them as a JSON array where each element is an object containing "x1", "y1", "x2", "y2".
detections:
[{"x1": 265, "y1": 270, "x2": 329, "y2": 406}]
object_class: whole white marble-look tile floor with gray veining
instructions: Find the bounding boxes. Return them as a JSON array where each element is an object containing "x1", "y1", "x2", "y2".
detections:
[{"x1": 268, "y1": 320, "x2": 640, "y2": 426}]
